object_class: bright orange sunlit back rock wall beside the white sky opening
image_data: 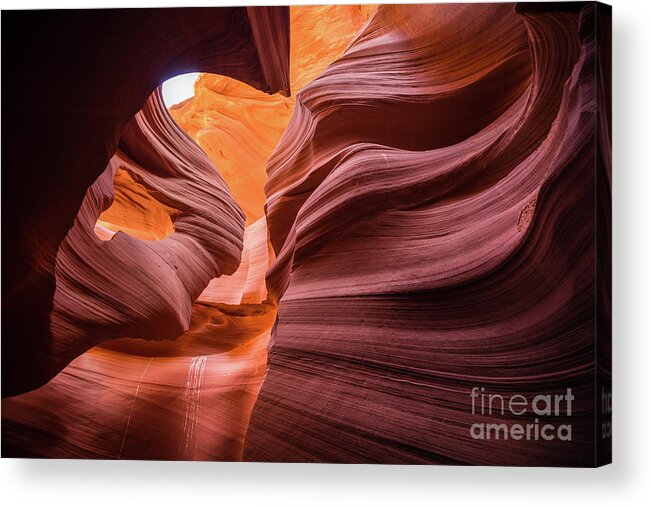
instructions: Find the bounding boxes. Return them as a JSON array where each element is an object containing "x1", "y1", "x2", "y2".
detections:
[{"x1": 170, "y1": 5, "x2": 377, "y2": 224}]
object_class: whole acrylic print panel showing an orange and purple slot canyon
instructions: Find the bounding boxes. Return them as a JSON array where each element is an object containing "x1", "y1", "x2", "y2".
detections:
[{"x1": 2, "y1": 2, "x2": 611, "y2": 466}]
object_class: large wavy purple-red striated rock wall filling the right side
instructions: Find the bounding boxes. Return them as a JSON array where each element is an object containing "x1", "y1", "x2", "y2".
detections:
[{"x1": 244, "y1": 4, "x2": 612, "y2": 465}]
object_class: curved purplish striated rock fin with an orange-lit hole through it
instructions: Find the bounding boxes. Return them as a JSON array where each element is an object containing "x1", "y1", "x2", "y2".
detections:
[{"x1": 50, "y1": 90, "x2": 247, "y2": 366}]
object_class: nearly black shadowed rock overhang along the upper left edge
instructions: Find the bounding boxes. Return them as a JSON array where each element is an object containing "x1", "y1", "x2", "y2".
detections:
[{"x1": 2, "y1": 7, "x2": 289, "y2": 396}]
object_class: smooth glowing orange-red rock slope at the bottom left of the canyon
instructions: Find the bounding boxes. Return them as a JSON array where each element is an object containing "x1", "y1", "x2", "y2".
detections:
[{"x1": 2, "y1": 303, "x2": 275, "y2": 461}]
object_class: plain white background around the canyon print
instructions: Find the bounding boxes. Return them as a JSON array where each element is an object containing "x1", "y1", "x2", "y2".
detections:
[{"x1": 0, "y1": 0, "x2": 651, "y2": 507}]
